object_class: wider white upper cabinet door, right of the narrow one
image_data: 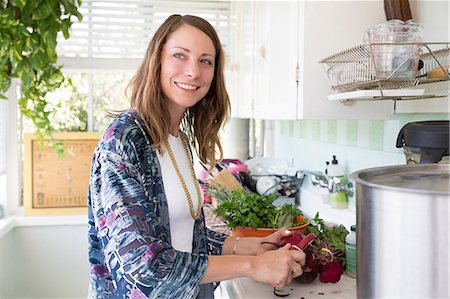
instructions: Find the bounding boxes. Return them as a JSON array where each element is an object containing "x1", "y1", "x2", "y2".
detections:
[{"x1": 254, "y1": 1, "x2": 299, "y2": 119}]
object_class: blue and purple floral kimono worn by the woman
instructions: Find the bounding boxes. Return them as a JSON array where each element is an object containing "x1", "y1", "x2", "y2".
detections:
[{"x1": 88, "y1": 109, "x2": 226, "y2": 299}]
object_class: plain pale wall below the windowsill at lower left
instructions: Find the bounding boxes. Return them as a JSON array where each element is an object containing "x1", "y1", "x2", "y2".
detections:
[{"x1": 0, "y1": 225, "x2": 89, "y2": 299}]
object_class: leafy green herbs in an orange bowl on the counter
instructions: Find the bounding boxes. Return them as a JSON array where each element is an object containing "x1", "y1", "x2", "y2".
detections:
[{"x1": 207, "y1": 184, "x2": 308, "y2": 236}]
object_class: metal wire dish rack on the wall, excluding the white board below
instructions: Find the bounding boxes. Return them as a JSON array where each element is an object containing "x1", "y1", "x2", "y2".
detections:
[{"x1": 319, "y1": 42, "x2": 450, "y2": 98}]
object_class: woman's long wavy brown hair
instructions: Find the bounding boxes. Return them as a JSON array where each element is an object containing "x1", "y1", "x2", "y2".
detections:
[{"x1": 127, "y1": 14, "x2": 230, "y2": 166}]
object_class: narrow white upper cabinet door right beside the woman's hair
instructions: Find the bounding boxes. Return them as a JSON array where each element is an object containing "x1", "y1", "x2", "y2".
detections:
[{"x1": 226, "y1": 1, "x2": 254, "y2": 118}]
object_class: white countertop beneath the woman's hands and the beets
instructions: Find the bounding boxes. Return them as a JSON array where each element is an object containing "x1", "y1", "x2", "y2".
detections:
[{"x1": 220, "y1": 274, "x2": 356, "y2": 299}]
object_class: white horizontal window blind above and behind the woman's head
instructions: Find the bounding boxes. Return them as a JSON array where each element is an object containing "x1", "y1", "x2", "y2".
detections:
[{"x1": 58, "y1": 0, "x2": 230, "y2": 60}]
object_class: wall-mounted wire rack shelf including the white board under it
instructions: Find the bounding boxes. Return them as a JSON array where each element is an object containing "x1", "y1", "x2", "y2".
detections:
[{"x1": 320, "y1": 42, "x2": 450, "y2": 101}]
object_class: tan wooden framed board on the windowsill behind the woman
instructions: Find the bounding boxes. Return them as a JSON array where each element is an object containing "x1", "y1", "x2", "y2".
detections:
[{"x1": 23, "y1": 132, "x2": 101, "y2": 216}]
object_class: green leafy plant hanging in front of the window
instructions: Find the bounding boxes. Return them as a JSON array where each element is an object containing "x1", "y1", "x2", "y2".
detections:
[{"x1": 0, "y1": 0, "x2": 82, "y2": 153}]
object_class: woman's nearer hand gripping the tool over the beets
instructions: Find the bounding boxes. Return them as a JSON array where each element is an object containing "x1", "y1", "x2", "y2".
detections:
[{"x1": 250, "y1": 245, "x2": 305, "y2": 288}]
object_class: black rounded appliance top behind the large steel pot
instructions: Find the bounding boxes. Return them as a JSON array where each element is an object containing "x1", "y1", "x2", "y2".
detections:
[{"x1": 396, "y1": 120, "x2": 450, "y2": 149}]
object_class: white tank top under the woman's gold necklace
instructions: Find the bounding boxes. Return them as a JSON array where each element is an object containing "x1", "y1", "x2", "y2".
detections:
[{"x1": 157, "y1": 134, "x2": 203, "y2": 252}]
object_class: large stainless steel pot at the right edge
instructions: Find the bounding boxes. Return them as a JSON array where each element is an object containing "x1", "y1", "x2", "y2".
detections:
[{"x1": 350, "y1": 164, "x2": 450, "y2": 299}]
